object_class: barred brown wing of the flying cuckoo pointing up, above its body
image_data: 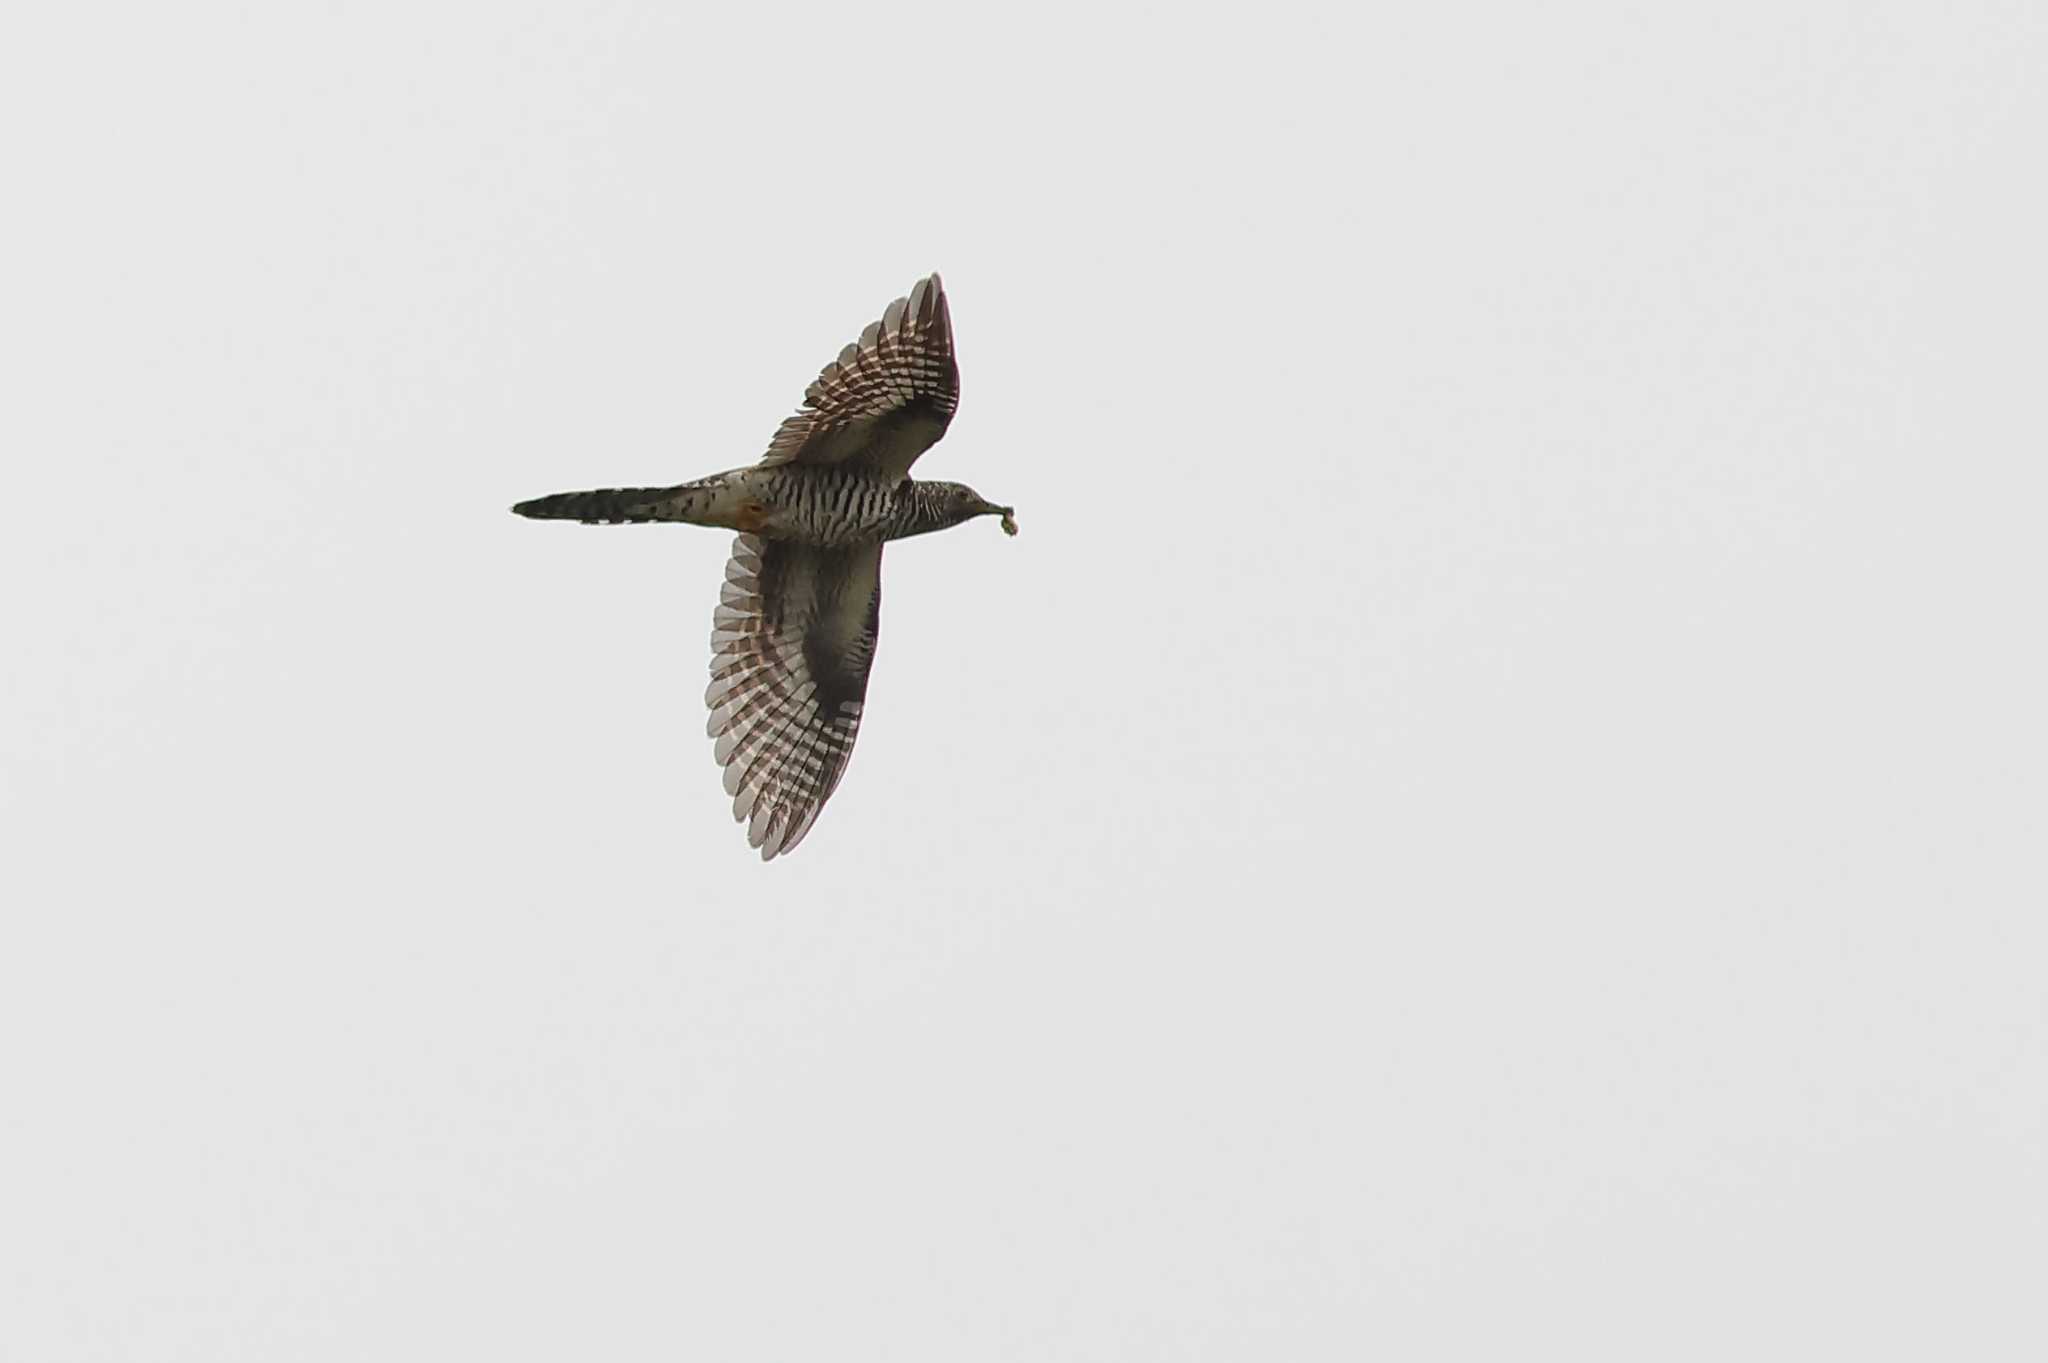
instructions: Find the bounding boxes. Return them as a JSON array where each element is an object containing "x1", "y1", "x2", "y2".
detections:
[{"x1": 762, "y1": 274, "x2": 961, "y2": 483}]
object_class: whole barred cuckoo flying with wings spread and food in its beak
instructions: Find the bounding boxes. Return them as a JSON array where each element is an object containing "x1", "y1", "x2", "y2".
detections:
[{"x1": 512, "y1": 274, "x2": 1018, "y2": 862}]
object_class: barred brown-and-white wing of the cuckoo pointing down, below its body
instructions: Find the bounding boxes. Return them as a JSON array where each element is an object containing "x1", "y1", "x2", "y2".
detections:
[{"x1": 705, "y1": 534, "x2": 883, "y2": 862}]
